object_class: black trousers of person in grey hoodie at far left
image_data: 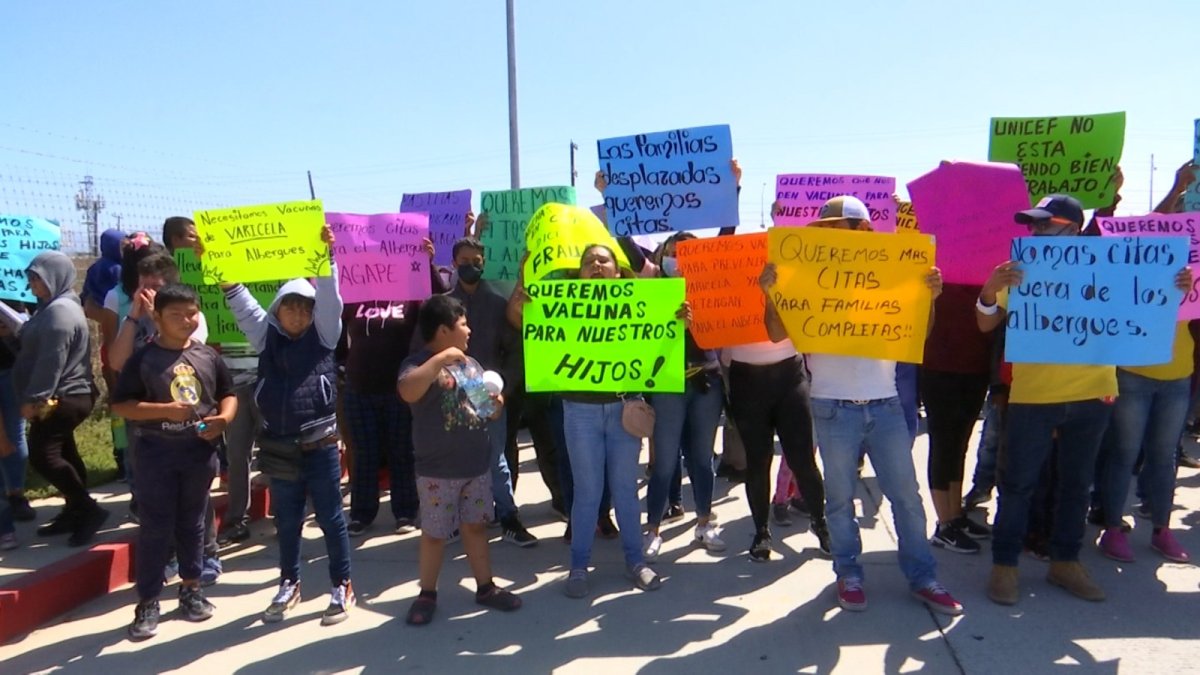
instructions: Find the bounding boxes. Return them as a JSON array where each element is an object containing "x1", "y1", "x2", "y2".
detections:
[{"x1": 29, "y1": 394, "x2": 96, "y2": 510}]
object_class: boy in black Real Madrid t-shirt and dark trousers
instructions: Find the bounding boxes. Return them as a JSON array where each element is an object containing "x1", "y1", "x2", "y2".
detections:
[{"x1": 112, "y1": 283, "x2": 238, "y2": 639}]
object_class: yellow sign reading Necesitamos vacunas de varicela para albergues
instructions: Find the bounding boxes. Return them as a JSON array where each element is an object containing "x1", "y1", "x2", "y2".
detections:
[{"x1": 194, "y1": 199, "x2": 329, "y2": 283}]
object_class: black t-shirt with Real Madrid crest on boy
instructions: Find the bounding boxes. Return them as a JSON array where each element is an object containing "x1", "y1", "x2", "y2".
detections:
[{"x1": 112, "y1": 341, "x2": 234, "y2": 438}]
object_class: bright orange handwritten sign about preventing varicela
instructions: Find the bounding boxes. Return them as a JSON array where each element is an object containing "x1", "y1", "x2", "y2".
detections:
[{"x1": 676, "y1": 232, "x2": 768, "y2": 350}]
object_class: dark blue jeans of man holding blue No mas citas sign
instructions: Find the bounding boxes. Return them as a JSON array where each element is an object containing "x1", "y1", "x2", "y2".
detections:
[{"x1": 991, "y1": 399, "x2": 1112, "y2": 566}]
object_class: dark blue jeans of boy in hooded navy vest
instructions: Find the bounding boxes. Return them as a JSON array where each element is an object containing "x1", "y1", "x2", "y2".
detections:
[{"x1": 271, "y1": 446, "x2": 350, "y2": 586}]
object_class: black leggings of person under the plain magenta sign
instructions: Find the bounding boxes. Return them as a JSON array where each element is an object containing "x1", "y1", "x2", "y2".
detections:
[{"x1": 920, "y1": 370, "x2": 988, "y2": 491}]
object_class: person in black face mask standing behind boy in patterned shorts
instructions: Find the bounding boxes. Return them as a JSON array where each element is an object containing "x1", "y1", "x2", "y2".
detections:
[{"x1": 449, "y1": 237, "x2": 538, "y2": 548}]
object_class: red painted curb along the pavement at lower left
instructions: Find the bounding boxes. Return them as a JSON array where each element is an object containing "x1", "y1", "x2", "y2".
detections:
[{"x1": 0, "y1": 485, "x2": 270, "y2": 644}]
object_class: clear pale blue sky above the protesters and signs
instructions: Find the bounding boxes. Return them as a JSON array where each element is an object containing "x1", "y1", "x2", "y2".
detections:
[{"x1": 0, "y1": 0, "x2": 1200, "y2": 248}]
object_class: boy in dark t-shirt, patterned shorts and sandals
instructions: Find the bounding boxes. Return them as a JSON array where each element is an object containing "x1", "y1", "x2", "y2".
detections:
[{"x1": 397, "y1": 295, "x2": 521, "y2": 626}]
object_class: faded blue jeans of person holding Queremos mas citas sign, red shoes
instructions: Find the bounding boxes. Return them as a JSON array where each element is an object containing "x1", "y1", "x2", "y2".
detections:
[{"x1": 812, "y1": 396, "x2": 937, "y2": 590}]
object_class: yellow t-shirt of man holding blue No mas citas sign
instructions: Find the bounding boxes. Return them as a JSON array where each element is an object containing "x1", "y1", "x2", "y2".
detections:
[{"x1": 996, "y1": 288, "x2": 1117, "y2": 404}]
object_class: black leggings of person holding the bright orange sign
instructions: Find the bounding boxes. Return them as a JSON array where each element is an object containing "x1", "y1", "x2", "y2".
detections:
[{"x1": 730, "y1": 357, "x2": 824, "y2": 532}]
